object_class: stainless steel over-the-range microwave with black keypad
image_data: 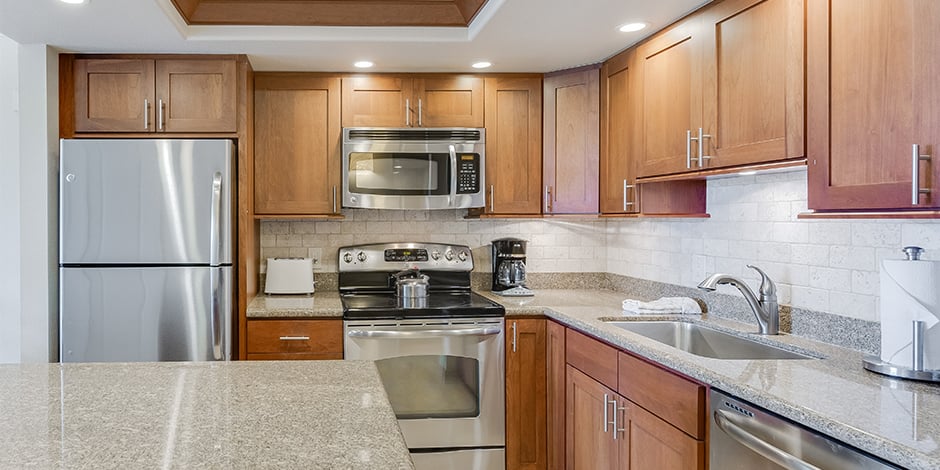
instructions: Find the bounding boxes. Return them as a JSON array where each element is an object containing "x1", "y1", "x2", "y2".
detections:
[{"x1": 343, "y1": 127, "x2": 486, "y2": 209}]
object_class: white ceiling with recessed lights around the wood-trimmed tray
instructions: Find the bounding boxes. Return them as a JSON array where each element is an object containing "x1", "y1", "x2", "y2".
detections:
[{"x1": 0, "y1": 0, "x2": 707, "y2": 72}]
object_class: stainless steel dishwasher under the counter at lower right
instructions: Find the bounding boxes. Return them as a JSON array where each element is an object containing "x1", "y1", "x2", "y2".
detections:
[{"x1": 709, "y1": 389, "x2": 901, "y2": 470}]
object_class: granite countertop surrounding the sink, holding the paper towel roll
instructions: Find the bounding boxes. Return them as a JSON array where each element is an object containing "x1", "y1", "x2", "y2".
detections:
[{"x1": 482, "y1": 290, "x2": 940, "y2": 470}]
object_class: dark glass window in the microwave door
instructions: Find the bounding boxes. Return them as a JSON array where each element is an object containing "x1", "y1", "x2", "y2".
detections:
[{"x1": 348, "y1": 152, "x2": 450, "y2": 196}]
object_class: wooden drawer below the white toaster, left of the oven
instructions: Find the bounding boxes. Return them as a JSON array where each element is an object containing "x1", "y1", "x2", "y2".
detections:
[{"x1": 248, "y1": 320, "x2": 343, "y2": 359}]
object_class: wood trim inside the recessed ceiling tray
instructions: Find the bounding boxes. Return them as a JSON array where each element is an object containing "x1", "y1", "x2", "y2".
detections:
[{"x1": 172, "y1": 0, "x2": 486, "y2": 27}]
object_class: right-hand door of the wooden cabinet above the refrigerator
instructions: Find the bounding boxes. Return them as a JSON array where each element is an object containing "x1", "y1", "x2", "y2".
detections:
[{"x1": 156, "y1": 59, "x2": 237, "y2": 132}]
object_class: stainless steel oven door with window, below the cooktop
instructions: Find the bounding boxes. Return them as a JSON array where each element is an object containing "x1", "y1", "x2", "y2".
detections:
[{"x1": 344, "y1": 318, "x2": 505, "y2": 449}]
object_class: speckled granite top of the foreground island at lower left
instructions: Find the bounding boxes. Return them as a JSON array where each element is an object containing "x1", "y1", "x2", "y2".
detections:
[{"x1": 0, "y1": 361, "x2": 414, "y2": 469}]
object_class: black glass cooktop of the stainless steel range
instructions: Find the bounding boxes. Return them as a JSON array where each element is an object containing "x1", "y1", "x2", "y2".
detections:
[{"x1": 342, "y1": 292, "x2": 506, "y2": 319}]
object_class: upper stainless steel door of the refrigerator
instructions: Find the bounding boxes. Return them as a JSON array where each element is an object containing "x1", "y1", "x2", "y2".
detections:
[{"x1": 59, "y1": 139, "x2": 234, "y2": 265}]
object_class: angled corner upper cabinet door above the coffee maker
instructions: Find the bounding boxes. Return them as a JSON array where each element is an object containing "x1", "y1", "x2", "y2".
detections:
[{"x1": 542, "y1": 68, "x2": 600, "y2": 214}]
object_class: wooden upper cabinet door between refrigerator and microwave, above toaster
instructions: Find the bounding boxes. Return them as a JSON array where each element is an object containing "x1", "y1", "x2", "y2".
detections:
[{"x1": 254, "y1": 74, "x2": 341, "y2": 215}]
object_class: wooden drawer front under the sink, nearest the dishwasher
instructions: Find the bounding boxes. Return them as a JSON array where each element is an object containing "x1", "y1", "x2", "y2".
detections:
[{"x1": 617, "y1": 352, "x2": 706, "y2": 439}]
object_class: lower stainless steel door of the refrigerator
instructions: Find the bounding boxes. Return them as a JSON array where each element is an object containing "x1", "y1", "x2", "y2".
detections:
[{"x1": 59, "y1": 267, "x2": 233, "y2": 362}]
